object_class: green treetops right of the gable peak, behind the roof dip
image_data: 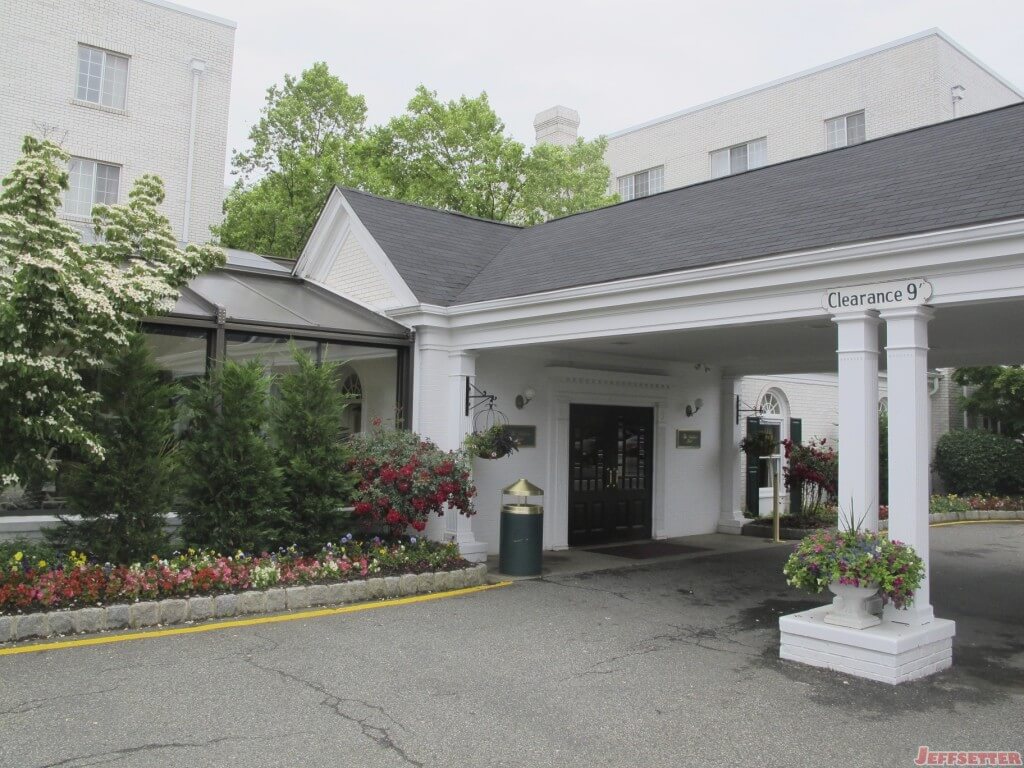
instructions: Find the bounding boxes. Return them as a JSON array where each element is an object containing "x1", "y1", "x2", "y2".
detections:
[{"x1": 353, "y1": 85, "x2": 616, "y2": 224}]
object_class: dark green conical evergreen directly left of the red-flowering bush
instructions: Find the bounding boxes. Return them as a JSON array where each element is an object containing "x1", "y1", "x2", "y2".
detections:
[{"x1": 273, "y1": 350, "x2": 355, "y2": 551}]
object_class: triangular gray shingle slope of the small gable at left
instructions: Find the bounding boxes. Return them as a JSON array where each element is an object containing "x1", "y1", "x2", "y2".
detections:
[{"x1": 339, "y1": 187, "x2": 521, "y2": 305}]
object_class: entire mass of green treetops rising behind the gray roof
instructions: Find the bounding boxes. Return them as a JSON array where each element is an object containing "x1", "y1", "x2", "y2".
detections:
[{"x1": 217, "y1": 62, "x2": 616, "y2": 258}]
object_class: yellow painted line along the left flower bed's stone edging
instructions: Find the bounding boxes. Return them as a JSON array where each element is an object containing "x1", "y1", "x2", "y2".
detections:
[{"x1": 0, "y1": 582, "x2": 512, "y2": 656}]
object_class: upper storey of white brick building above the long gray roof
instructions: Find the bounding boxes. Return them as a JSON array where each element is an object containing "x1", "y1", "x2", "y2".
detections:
[{"x1": 598, "y1": 29, "x2": 1024, "y2": 199}]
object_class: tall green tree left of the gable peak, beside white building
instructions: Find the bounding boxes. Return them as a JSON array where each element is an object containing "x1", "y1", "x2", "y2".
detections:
[{"x1": 214, "y1": 61, "x2": 367, "y2": 258}]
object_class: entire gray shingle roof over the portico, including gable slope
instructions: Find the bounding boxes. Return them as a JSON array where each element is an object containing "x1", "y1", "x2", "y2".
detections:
[{"x1": 344, "y1": 104, "x2": 1024, "y2": 304}]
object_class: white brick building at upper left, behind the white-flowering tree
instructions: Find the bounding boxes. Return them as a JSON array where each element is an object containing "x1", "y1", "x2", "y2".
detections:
[{"x1": 0, "y1": 0, "x2": 234, "y2": 242}]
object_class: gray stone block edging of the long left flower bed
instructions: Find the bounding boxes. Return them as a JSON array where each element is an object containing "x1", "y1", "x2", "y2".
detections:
[{"x1": 0, "y1": 564, "x2": 487, "y2": 643}]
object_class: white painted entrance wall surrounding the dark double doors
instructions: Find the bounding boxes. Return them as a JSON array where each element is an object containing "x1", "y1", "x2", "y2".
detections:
[{"x1": 464, "y1": 348, "x2": 720, "y2": 553}]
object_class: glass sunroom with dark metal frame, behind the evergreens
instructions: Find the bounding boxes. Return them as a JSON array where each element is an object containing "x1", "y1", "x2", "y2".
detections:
[{"x1": 144, "y1": 249, "x2": 412, "y2": 432}]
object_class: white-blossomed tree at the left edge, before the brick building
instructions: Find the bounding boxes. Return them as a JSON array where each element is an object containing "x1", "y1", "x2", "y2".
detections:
[{"x1": 0, "y1": 136, "x2": 224, "y2": 489}]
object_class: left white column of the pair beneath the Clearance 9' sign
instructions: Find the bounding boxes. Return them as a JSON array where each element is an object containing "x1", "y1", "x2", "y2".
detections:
[{"x1": 833, "y1": 310, "x2": 880, "y2": 530}]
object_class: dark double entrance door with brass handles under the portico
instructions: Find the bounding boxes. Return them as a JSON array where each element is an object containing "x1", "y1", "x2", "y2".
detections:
[{"x1": 568, "y1": 406, "x2": 654, "y2": 547}]
